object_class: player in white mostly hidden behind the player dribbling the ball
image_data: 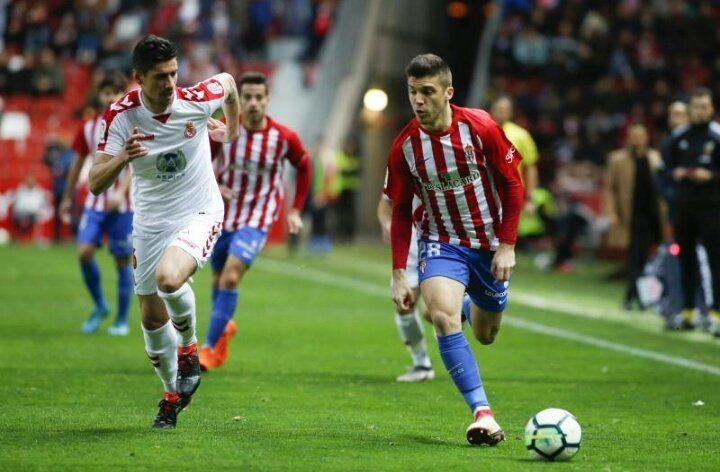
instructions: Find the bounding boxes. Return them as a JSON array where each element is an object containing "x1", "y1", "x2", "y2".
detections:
[{"x1": 377, "y1": 192, "x2": 435, "y2": 382}]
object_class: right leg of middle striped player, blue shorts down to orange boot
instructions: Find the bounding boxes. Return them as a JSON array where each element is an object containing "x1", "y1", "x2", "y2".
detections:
[{"x1": 205, "y1": 227, "x2": 267, "y2": 365}]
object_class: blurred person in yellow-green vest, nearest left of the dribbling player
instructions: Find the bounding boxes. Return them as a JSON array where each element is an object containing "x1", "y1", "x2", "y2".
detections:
[{"x1": 334, "y1": 137, "x2": 361, "y2": 243}]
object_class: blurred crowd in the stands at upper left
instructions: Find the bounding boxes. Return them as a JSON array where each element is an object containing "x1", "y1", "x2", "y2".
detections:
[{"x1": 0, "y1": 0, "x2": 337, "y2": 95}]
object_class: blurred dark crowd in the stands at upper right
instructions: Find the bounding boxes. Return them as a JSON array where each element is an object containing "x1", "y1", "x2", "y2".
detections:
[{"x1": 491, "y1": 0, "x2": 720, "y2": 170}]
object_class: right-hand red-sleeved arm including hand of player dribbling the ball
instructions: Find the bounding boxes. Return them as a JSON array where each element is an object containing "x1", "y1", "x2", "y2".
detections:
[{"x1": 481, "y1": 122, "x2": 524, "y2": 281}]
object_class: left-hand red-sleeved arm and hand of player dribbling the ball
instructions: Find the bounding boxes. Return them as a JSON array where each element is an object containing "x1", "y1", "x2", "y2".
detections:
[{"x1": 386, "y1": 143, "x2": 415, "y2": 310}]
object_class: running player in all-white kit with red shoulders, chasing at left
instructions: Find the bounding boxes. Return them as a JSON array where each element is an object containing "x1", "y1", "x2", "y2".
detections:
[{"x1": 90, "y1": 35, "x2": 239, "y2": 428}]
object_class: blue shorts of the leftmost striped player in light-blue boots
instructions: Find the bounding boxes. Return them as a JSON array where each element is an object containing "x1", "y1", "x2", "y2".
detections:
[{"x1": 76, "y1": 210, "x2": 133, "y2": 257}]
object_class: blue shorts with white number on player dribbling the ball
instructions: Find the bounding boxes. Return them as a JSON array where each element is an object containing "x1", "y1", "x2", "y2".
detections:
[{"x1": 418, "y1": 241, "x2": 510, "y2": 312}]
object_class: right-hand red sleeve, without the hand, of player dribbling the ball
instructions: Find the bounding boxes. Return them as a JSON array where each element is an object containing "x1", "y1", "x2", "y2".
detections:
[{"x1": 480, "y1": 121, "x2": 524, "y2": 244}]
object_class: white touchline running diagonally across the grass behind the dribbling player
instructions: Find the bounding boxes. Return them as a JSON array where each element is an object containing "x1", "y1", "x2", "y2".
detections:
[{"x1": 256, "y1": 259, "x2": 720, "y2": 377}]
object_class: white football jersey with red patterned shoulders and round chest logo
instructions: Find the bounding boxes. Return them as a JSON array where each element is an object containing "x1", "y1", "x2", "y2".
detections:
[{"x1": 97, "y1": 79, "x2": 224, "y2": 232}]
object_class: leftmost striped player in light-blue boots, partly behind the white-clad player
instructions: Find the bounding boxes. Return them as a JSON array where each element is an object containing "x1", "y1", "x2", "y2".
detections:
[{"x1": 60, "y1": 73, "x2": 132, "y2": 336}]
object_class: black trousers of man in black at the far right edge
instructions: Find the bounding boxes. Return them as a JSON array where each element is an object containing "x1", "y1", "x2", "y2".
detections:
[{"x1": 674, "y1": 202, "x2": 720, "y2": 310}]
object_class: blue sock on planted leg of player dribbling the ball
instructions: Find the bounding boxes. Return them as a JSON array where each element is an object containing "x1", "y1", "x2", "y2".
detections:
[{"x1": 437, "y1": 331, "x2": 488, "y2": 412}]
